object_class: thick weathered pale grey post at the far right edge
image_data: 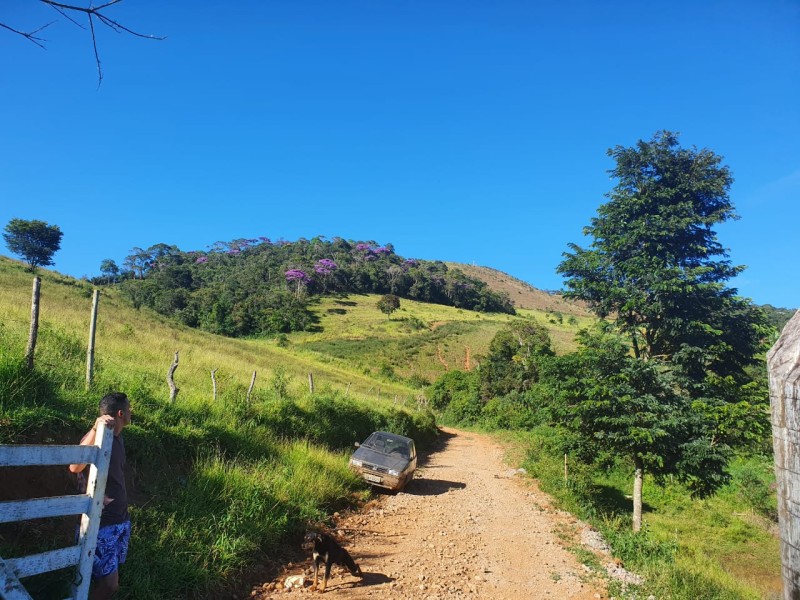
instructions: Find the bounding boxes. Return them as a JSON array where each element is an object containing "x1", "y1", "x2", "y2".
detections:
[{"x1": 767, "y1": 311, "x2": 800, "y2": 600}]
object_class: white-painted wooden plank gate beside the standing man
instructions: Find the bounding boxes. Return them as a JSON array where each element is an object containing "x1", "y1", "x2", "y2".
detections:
[{"x1": 0, "y1": 424, "x2": 114, "y2": 600}]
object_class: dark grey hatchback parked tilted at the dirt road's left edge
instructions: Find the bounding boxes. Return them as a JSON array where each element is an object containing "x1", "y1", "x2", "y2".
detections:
[{"x1": 350, "y1": 431, "x2": 417, "y2": 492}]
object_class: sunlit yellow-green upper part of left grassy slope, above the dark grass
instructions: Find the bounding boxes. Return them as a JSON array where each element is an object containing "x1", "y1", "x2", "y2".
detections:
[{"x1": 0, "y1": 258, "x2": 413, "y2": 401}]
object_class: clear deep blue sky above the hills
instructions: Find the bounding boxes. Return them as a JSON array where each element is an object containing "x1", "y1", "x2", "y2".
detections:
[{"x1": 0, "y1": 0, "x2": 800, "y2": 307}]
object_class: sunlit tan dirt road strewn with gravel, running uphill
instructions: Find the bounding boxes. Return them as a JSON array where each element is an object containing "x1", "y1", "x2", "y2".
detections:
[{"x1": 251, "y1": 429, "x2": 607, "y2": 600}]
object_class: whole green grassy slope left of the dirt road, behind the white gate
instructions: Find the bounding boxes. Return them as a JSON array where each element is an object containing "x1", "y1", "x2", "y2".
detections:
[{"x1": 0, "y1": 259, "x2": 435, "y2": 600}]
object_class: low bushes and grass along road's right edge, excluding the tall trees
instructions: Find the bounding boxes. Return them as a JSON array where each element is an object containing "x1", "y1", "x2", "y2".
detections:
[{"x1": 429, "y1": 324, "x2": 781, "y2": 600}]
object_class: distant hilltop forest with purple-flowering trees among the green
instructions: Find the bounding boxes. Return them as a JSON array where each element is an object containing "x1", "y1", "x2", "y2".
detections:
[{"x1": 109, "y1": 237, "x2": 514, "y2": 337}]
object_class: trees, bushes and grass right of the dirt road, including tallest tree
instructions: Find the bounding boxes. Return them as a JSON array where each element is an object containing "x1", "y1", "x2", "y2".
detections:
[{"x1": 429, "y1": 132, "x2": 781, "y2": 600}]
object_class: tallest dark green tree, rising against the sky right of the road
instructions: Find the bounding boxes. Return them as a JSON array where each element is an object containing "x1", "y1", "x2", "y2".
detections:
[{"x1": 558, "y1": 131, "x2": 767, "y2": 528}]
